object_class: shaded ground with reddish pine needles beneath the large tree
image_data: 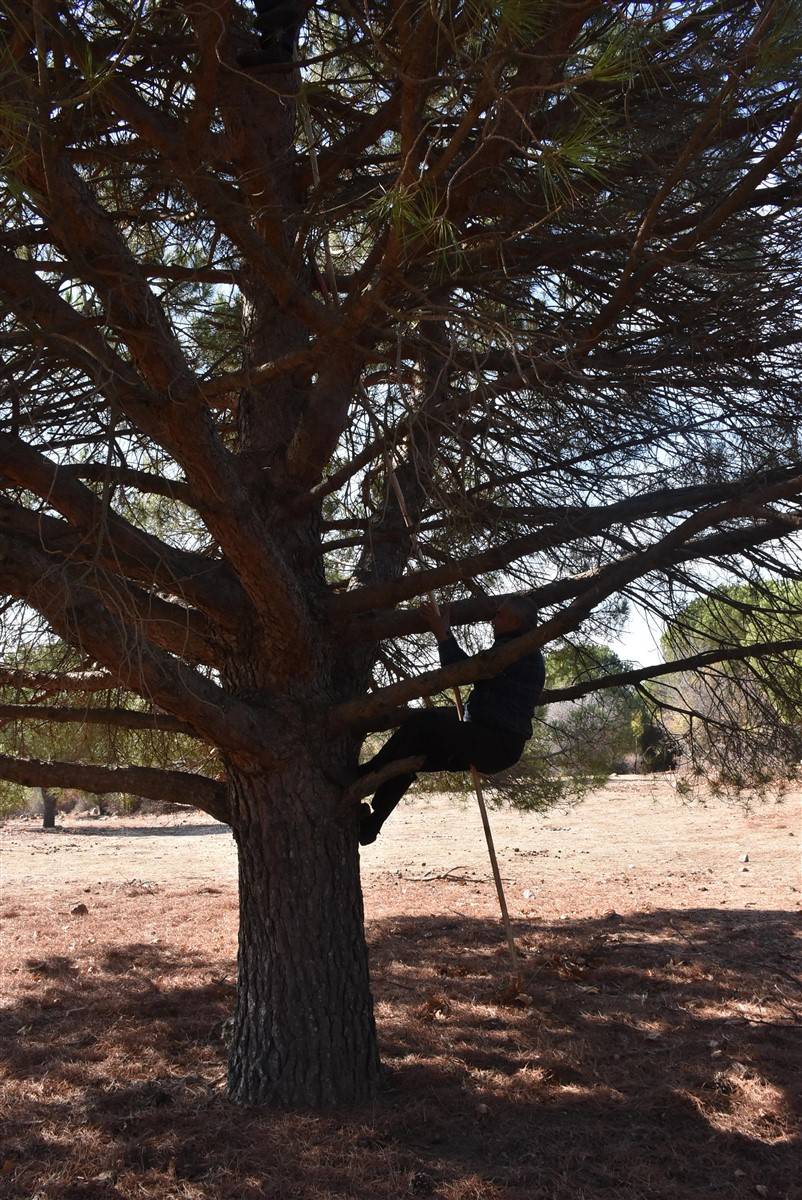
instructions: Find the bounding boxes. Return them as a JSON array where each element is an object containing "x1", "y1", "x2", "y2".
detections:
[{"x1": 0, "y1": 910, "x2": 802, "y2": 1200}]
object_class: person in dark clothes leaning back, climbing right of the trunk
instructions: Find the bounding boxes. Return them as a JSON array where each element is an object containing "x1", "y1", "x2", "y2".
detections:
[{"x1": 359, "y1": 596, "x2": 546, "y2": 846}]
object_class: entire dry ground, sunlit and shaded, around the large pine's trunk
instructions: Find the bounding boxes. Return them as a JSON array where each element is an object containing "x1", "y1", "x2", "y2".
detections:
[{"x1": 0, "y1": 778, "x2": 802, "y2": 1200}]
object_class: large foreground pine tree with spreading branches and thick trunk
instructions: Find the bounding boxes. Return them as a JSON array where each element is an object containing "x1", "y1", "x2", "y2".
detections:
[{"x1": 0, "y1": 0, "x2": 802, "y2": 1105}]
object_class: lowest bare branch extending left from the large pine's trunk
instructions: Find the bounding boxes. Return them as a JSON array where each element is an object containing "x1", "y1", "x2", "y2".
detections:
[{"x1": 0, "y1": 755, "x2": 231, "y2": 824}]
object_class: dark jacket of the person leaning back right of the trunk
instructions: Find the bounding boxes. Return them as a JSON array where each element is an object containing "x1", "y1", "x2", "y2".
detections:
[{"x1": 438, "y1": 634, "x2": 546, "y2": 738}]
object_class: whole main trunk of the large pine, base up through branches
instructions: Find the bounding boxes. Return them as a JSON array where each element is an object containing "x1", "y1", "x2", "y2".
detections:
[{"x1": 214, "y1": 49, "x2": 378, "y2": 1108}]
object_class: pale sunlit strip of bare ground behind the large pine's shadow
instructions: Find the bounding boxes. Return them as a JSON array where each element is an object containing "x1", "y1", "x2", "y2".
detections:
[{"x1": 0, "y1": 776, "x2": 802, "y2": 918}]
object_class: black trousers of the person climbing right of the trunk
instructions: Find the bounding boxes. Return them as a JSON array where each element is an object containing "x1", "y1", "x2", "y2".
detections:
[{"x1": 359, "y1": 706, "x2": 526, "y2": 845}]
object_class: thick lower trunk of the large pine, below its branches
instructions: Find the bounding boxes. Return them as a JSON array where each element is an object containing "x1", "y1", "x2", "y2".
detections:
[{"x1": 222, "y1": 760, "x2": 378, "y2": 1108}]
